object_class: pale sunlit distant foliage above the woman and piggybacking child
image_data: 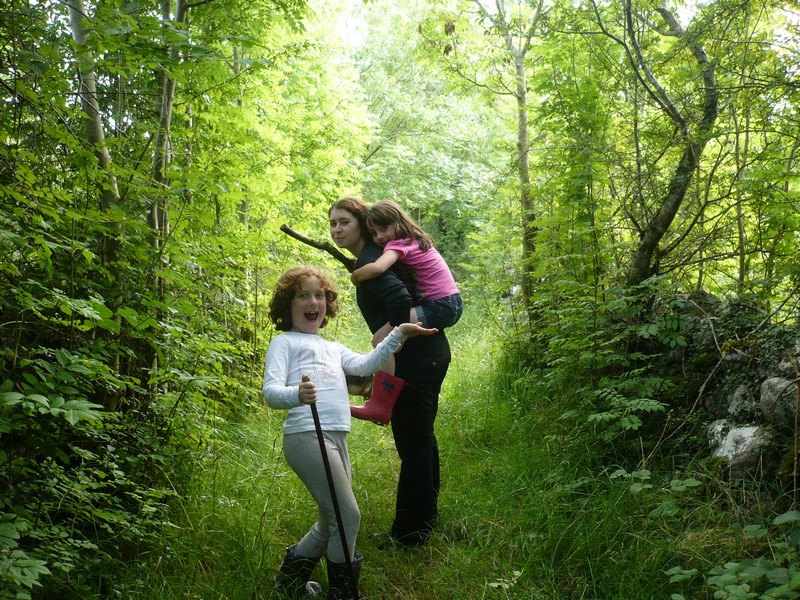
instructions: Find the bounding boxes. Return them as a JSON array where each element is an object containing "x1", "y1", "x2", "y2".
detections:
[{"x1": 356, "y1": 4, "x2": 508, "y2": 276}]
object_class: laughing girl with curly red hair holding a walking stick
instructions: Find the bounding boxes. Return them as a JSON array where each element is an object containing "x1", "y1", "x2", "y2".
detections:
[{"x1": 262, "y1": 266, "x2": 437, "y2": 599}]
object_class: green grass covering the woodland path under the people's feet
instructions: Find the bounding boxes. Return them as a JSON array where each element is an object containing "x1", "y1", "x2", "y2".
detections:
[{"x1": 109, "y1": 316, "x2": 780, "y2": 600}]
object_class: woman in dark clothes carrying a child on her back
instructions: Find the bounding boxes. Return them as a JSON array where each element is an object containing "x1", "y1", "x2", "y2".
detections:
[{"x1": 328, "y1": 197, "x2": 450, "y2": 547}]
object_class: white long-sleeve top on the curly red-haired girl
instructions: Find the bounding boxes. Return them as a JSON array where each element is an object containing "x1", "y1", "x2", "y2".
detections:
[{"x1": 261, "y1": 328, "x2": 406, "y2": 434}]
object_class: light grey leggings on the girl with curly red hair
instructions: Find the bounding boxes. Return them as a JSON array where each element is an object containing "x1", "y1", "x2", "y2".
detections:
[{"x1": 283, "y1": 431, "x2": 361, "y2": 563}]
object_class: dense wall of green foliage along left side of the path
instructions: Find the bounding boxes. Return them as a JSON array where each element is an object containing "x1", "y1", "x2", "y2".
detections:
[{"x1": 0, "y1": 2, "x2": 365, "y2": 598}]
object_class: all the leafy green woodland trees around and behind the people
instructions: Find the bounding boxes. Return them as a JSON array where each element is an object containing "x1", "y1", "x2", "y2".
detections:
[{"x1": 0, "y1": 0, "x2": 800, "y2": 598}]
